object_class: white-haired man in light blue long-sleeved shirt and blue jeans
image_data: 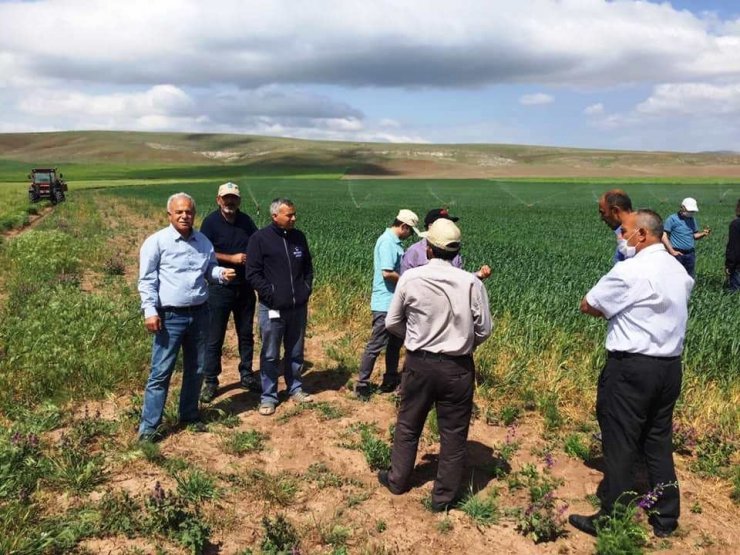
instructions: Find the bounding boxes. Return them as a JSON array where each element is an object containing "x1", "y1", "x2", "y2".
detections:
[{"x1": 139, "y1": 193, "x2": 235, "y2": 441}]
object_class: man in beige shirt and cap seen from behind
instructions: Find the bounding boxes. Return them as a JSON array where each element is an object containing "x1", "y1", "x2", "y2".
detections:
[{"x1": 378, "y1": 219, "x2": 491, "y2": 511}]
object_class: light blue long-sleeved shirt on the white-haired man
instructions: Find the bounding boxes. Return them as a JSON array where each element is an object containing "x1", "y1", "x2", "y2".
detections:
[{"x1": 139, "y1": 225, "x2": 223, "y2": 318}]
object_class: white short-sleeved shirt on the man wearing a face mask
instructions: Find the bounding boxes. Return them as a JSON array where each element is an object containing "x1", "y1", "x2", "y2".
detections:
[{"x1": 586, "y1": 243, "x2": 694, "y2": 357}]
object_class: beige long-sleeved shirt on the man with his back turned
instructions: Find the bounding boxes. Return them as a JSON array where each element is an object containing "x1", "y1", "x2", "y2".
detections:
[{"x1": 385, "y1": 258, "x2": 492, "y2": 356}]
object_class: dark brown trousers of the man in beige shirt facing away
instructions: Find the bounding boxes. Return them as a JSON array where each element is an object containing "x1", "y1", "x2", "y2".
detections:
[{"x1": 388, "y1": 352, "x2": 475, "y2": 505}]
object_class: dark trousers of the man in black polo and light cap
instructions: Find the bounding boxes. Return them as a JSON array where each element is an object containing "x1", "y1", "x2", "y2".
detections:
[{"x1": 203, "y1": 284, "x2": 255, "y2": 384}]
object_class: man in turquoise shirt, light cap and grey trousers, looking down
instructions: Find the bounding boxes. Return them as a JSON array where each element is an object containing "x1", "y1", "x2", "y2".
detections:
[{"x1": 355, "y1": 209, "x2": 420, "y2": 399}]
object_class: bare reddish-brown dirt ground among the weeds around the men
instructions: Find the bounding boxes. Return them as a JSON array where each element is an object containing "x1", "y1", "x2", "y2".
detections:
[{"x1": 56, "y1": 193, "x2": 740, "y2": 554}]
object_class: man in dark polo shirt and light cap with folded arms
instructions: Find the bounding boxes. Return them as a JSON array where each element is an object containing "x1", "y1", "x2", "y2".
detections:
[{"x1": 200, "y1": 182, "x2": 261, "y2": 403}]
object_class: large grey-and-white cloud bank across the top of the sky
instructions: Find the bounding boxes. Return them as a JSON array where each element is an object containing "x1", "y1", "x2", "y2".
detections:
[{"x1": 0, "y1": 0, "x2": 740, "y2": 88}]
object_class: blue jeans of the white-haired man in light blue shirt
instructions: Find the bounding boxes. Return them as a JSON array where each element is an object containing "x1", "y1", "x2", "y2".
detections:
[{"x1": 139, "y1": 305, "x2": 209, "y2": 436}]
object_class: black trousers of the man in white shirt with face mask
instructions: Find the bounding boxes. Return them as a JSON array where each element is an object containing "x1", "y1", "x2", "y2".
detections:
[{"x1": 596, "y1": 353, "x2": 681, "y2": 530}]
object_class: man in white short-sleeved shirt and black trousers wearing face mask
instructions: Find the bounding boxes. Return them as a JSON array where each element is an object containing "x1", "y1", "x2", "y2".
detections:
[{"x1": 569, "y1": 210, "x2": 694, "y2": 537}]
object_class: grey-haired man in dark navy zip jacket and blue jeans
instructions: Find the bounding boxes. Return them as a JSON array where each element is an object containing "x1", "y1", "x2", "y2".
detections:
[{"x1": 246, "y1": 198, "x2": 313, "y2": 416}]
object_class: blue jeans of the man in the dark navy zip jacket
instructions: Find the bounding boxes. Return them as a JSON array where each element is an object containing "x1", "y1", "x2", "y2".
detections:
[{"x1": 258, "y1": 303, "x2": 308, "y2": 405}]
